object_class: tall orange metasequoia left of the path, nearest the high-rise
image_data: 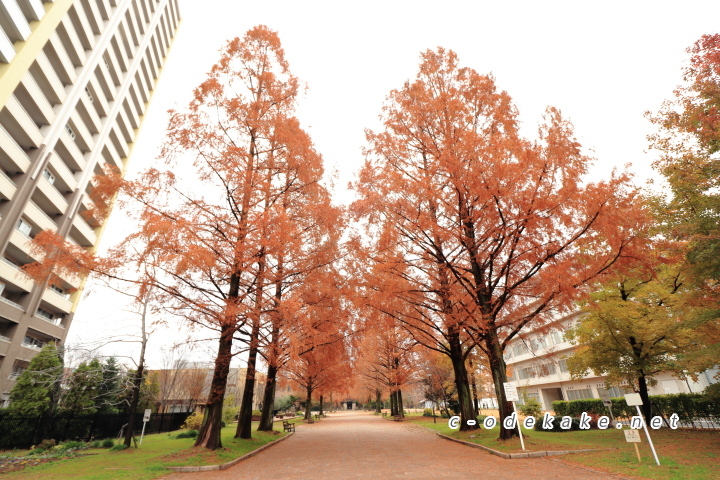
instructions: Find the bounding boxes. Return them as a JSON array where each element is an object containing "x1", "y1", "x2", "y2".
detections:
[{"x1": 25, "y1": 26, "x2": 337, "y2": 449}]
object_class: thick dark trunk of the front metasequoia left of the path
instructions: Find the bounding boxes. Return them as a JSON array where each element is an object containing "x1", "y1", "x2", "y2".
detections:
[{"x1": 195, "y1": 325, "x2": 235, "y2": 450}]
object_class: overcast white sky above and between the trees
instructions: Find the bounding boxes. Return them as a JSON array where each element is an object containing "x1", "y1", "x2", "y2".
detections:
[{"x1": 67, "y1": 0, "x2": 720, "y2": 368}]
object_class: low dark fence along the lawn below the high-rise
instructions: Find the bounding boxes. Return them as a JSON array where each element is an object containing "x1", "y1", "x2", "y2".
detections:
[{"x1": 0, "y1": 413, "x2": 190, "y2": 450}]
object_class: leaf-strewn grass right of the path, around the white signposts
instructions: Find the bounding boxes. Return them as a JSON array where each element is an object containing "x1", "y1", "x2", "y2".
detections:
[{"x1": 408, "y1": 417, "x2": 720, "y2": 480}]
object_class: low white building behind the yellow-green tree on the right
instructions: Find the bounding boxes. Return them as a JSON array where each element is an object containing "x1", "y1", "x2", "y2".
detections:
[{"x1": 505, "y1": 313, "x2": 717, "y2": 410}]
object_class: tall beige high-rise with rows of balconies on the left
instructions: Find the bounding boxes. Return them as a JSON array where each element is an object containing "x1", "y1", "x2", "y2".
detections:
[{"x1": 0, "y1": 0, "x2": 180, "y2": 405}]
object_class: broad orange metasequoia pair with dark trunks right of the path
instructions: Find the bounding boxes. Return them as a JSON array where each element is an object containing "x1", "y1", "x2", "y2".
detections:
[{"x1": 354, "y1": 48, "x2": 644, "y2": 439}]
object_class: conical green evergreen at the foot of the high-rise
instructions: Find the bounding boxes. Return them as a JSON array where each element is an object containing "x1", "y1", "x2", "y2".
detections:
[{"x1": 8, "y1": 343, "x2": 63, "y2": 416}]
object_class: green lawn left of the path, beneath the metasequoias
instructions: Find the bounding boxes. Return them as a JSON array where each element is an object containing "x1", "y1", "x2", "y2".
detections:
[{"x1": 3, "y1": 422, "x2": 285, "y2": 480}]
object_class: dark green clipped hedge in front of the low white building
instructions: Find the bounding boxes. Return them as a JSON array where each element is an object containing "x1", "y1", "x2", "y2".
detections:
[{"x1": 552, "y1": 393, "x2": 720, "y2": 422}]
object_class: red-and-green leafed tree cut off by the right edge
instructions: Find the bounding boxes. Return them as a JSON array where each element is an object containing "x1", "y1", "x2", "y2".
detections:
[{"x1": 649, "y1": 33, "x2": 720, "y2": 365}]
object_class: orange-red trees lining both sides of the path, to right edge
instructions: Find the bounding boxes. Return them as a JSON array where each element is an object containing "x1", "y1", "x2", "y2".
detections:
[{"x1": 22, "y1": 26, "x2": 720, "y2": 449}]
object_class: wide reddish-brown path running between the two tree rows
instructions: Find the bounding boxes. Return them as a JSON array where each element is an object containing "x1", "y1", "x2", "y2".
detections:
[{"x1": 163, "y1": 412, "x2": 618, "y2": 480}]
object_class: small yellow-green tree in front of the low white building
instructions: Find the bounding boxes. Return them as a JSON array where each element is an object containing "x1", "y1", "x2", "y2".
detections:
[{"x1": 566, "y1": 251, "x2": 714, "y2": 418}]
